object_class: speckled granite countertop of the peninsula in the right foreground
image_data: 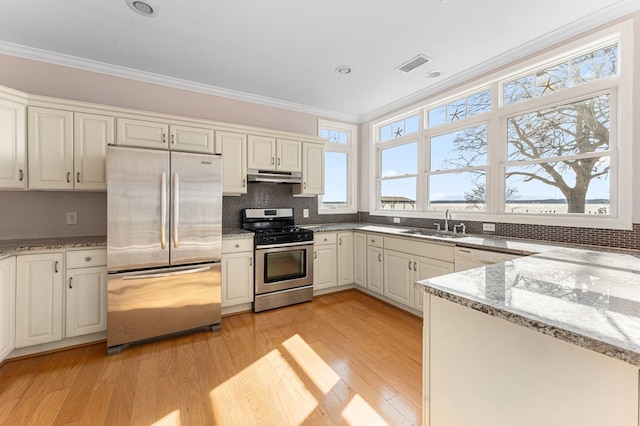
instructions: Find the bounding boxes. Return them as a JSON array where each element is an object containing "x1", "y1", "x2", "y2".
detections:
[{"x1": 416, "y1": 248, "x2": 640, "y2": 366}]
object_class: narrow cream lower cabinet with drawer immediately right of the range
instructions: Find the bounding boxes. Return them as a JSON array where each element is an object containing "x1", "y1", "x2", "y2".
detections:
[{"x1": 313, "y1": 232, "x2": 338, "y2": 291}]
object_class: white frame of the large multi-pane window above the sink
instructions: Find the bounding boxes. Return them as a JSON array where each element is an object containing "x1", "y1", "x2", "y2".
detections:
[{"x1": 369, "y1": 20, "x2": 634, "y2": 229}]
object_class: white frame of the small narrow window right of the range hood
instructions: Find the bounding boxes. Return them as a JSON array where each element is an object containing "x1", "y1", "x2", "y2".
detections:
[{"x1": 318, "y1": 119, "x2": 358, "y2": 214}]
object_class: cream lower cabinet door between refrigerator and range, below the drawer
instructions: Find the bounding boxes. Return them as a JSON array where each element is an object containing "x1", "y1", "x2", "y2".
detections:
[{"x1": 222, "y1": 252, "x2": 253, "y2": 308}]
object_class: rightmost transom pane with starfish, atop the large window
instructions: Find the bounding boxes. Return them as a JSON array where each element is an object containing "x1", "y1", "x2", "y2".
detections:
[{"x1": 503, "y1": 44, "x2": 618, "y2": 105}]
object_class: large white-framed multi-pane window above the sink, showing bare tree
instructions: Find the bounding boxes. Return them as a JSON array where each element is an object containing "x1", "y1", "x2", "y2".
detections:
[{"x1": 370, "y1": 22, "x2": 633, "y2": 229}]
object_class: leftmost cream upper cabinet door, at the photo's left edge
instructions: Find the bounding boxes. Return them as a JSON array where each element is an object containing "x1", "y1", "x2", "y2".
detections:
[{"x1": 0, "y1": 99, "x2": 27, "y2": 189}]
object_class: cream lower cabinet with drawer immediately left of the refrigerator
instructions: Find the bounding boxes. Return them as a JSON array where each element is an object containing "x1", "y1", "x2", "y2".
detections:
[{"x1": 65, "y1": 249, "x2": 107, "y2": 337}]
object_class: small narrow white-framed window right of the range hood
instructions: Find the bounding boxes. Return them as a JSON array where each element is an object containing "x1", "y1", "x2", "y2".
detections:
[{"x1": 318, "y1": 120, "x2": 358, "y2": 214}]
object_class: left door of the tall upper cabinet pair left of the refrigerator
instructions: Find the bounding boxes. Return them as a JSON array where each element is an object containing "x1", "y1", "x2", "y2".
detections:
[{"x1": 28, "y1": 107, "x2": 73, "y2": 189}]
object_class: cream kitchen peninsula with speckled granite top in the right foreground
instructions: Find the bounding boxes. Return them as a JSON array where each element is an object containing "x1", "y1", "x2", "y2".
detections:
[{"x1": 416, "y1": 248, "x2": 640, "y2": 426}]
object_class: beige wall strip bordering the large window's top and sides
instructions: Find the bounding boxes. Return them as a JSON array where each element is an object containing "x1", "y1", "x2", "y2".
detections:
[{"x1": 358, "y1": 13, "x2": 640, "y2": 223}]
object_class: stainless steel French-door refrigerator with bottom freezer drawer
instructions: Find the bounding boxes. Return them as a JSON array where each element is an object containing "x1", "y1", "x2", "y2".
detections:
[{"x1": 107, "y1": 146, "x2": 222, "y2": 354}]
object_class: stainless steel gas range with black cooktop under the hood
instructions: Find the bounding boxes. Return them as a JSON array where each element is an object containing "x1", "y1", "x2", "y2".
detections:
[{"x1": 242, "y1": 208, "x2": 313, "y2": 312}]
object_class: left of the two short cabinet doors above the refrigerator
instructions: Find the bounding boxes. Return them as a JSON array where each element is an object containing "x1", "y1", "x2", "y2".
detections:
[{"x1": 116, "y1": 118, "x2": 169, "y2": 149}]
